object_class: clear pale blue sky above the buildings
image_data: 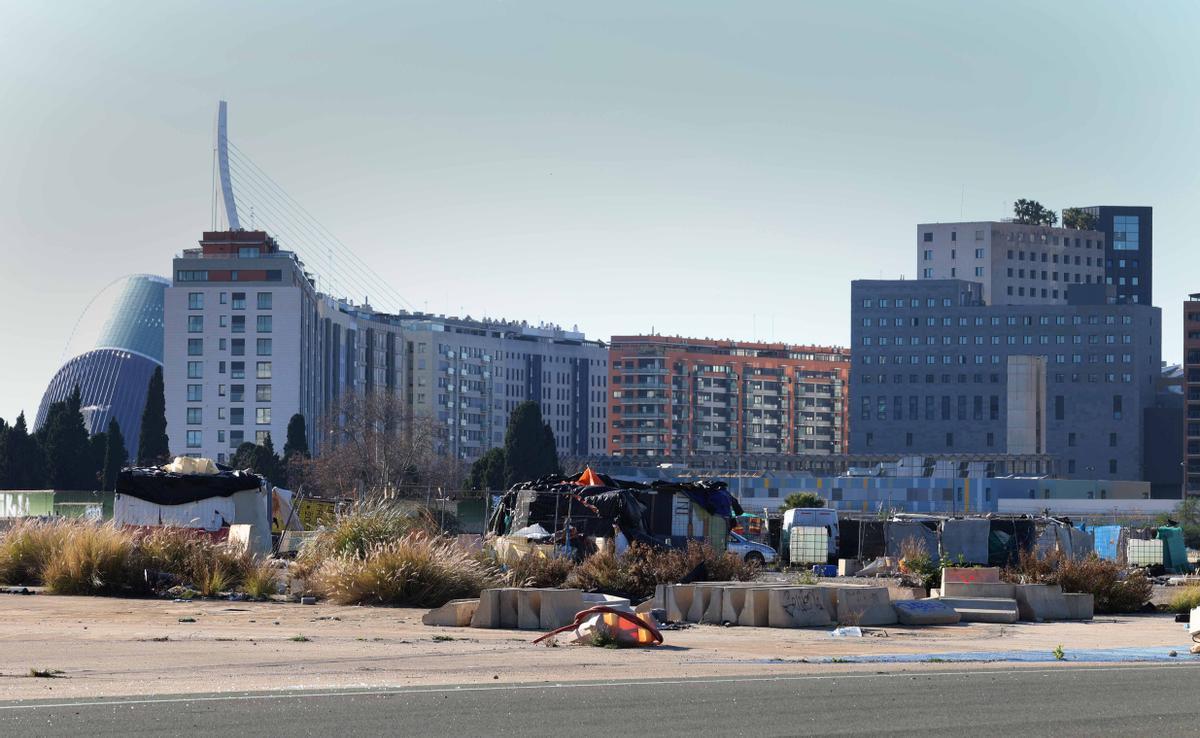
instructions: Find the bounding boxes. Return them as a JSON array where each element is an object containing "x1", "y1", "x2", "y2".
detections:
[{"x1": 0, "y1": 0, "x2": 1200, "y2": 420}]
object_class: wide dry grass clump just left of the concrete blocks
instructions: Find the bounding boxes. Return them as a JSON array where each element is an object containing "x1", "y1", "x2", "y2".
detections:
[{"x1": 313, "y1": 530, "x2": 499, "y2": 607}]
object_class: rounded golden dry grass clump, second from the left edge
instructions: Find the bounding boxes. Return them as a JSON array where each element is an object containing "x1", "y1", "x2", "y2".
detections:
[{"x1": 42, "y1": 523, "x2": 148, "y2": 594}]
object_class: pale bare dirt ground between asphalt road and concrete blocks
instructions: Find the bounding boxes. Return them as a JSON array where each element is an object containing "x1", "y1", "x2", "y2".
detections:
[{"x1": 0, "y1": 594, "x2": 1200, "y2": 700}]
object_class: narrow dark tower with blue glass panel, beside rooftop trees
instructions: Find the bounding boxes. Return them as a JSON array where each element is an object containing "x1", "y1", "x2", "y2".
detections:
[{"x1": 1081, "y1": 205, "x2": 1154, "y2": 305}]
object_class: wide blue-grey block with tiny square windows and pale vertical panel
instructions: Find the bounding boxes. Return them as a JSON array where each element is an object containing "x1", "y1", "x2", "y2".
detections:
[{"x1": 850, "y1": 279, "x2": 1162, "y2": 479}]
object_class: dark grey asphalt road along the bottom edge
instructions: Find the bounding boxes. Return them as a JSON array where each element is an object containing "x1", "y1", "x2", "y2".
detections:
[{"x1": 0, "y1": 665, "x2": 1200, "y2": 738}]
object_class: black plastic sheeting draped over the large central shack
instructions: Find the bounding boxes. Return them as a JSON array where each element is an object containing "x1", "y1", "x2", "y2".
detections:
[{"x1": 487, "y1": 474, "x2": 742, "y2": 546}]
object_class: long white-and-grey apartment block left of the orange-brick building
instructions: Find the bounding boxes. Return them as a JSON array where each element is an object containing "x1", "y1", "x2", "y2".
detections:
[{"x1": 163, "y1": 230, "x2": 607, "y2": 461}]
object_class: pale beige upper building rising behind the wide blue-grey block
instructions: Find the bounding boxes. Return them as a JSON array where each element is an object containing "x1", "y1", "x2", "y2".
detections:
[{"x1": 917, "y1": 221, "x2": 1104, "y2": 305}]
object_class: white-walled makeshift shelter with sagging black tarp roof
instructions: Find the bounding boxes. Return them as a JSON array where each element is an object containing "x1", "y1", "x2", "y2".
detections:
[{"x1": 113, "y1": 460, "x2": 272, "y2": 552}]
